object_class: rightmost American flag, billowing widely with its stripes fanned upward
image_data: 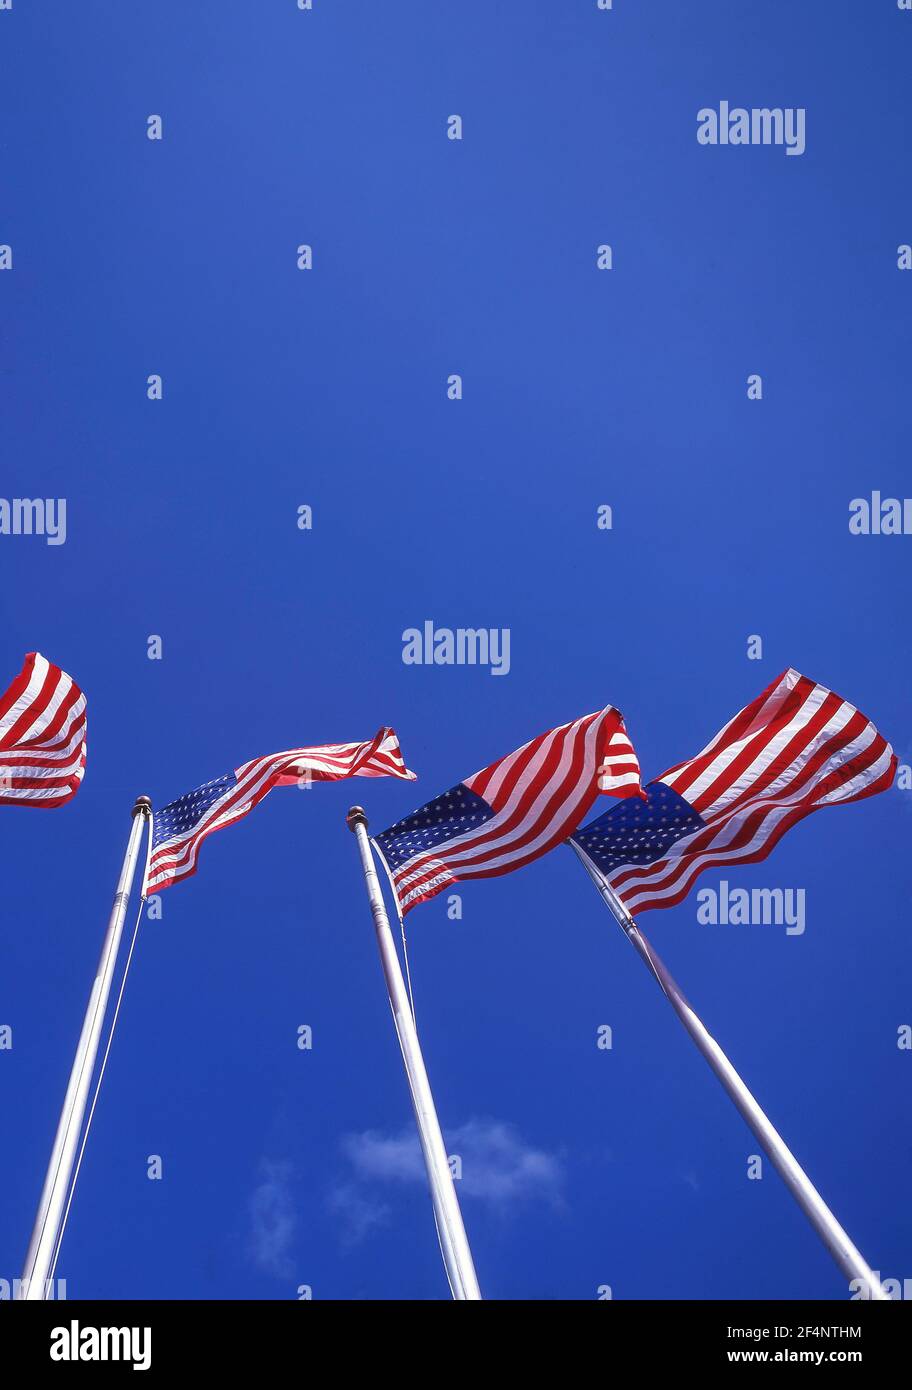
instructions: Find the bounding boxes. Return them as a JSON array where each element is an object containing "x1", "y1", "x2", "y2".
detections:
[{"x1": 573, "y1": 670, "x2": 897, "y2": 915}]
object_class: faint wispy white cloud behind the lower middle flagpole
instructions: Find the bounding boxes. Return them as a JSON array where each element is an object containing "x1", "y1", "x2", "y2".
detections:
[{"x1": 331, "y1": 1119, "x2": 564, "y2": 1241}]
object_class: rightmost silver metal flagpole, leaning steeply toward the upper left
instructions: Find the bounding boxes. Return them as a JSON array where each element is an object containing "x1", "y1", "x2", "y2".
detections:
[{"x1": 570, "y1": 840, "x2": 890, "y2": 1301}]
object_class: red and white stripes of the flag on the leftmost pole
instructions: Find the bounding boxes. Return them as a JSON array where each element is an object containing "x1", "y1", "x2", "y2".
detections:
[{"x1": 143, "y1": 728, "x2": 416, "y2": 895}]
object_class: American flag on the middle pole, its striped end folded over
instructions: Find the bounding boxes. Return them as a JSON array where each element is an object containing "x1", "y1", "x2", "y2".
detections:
[{"x1": 375, "y1": 705, "x2": 642, "y2": 915}]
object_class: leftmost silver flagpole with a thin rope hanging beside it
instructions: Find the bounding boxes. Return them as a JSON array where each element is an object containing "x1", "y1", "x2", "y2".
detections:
[{"x1": 18, "y1": 796, "x2": 152, "y2": 1301}]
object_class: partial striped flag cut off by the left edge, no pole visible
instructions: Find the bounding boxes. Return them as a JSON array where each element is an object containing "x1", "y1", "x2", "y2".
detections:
[{"x1": 0, "y1": 652, "x2": 86, "y2": 809}]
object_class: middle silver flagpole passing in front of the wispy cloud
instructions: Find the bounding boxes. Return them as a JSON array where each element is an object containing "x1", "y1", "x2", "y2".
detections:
[{"x1": 346, "y1": 806, "x2": 481, "y2": 1301}]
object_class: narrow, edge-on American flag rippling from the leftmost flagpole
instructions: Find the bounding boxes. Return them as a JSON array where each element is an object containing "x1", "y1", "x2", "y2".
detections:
[{"x1": 143, "y1": 728, "x2": 414, "y2": 895}]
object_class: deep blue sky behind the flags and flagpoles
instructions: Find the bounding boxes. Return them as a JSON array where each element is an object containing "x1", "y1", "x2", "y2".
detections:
[{"x1": 0, "y1": 0, "x2": 912, "y2": 1298}]
